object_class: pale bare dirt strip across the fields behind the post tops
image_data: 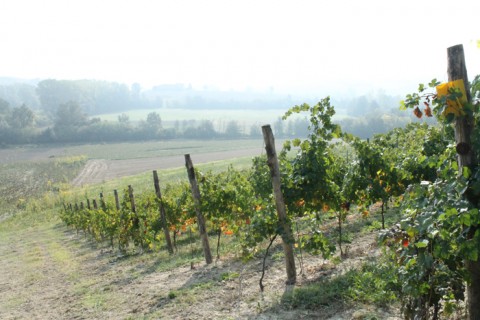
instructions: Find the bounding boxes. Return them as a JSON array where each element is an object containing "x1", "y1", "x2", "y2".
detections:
[{"x1": 72, "y1": 148, "x2": 263, "y2": 187}]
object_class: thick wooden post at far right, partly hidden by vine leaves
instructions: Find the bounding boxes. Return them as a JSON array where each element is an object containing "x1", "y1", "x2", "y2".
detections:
[{"x1": 447, "y1": 45, "x2": 480, "y2": 320}]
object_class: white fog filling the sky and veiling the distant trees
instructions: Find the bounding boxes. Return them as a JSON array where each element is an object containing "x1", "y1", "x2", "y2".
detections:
[{"x1": 0, "y1": 0, "x2": 480, "y2": 143}]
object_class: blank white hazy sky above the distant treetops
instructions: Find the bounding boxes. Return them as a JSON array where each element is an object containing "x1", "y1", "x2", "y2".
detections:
[{"x1": 0, "y1": 0, "x2": 480, "y2": 93}]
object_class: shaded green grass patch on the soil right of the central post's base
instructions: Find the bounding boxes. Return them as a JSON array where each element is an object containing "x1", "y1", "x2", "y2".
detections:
[{"x1": 282, "y1": 262, "x2": 400, "y2": 309}]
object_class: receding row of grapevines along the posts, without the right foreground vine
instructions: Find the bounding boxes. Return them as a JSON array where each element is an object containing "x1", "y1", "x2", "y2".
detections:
[{"x1": 61, "y1": 90, "x2": 466, "y2": 316}]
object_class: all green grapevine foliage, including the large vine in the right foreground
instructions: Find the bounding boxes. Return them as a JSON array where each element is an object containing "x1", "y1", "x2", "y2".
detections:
[{"x1": 61, "y1": 43, "x2": 480, "y2": 319}]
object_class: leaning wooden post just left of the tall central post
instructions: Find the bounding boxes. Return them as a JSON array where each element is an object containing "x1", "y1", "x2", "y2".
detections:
[{"x1": 185, "y1": 154, "x2": 213, "y2": 264}]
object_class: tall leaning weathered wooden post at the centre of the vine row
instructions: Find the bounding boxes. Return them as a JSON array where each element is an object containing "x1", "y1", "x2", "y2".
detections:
[{"x1": 262, "y1": 125, "x2": 297, "y2": 284}]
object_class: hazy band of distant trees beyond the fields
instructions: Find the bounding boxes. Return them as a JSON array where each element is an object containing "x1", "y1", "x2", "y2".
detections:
[{"x1": 0, "y1": 79, "x2": 430, "y2": 145}]
